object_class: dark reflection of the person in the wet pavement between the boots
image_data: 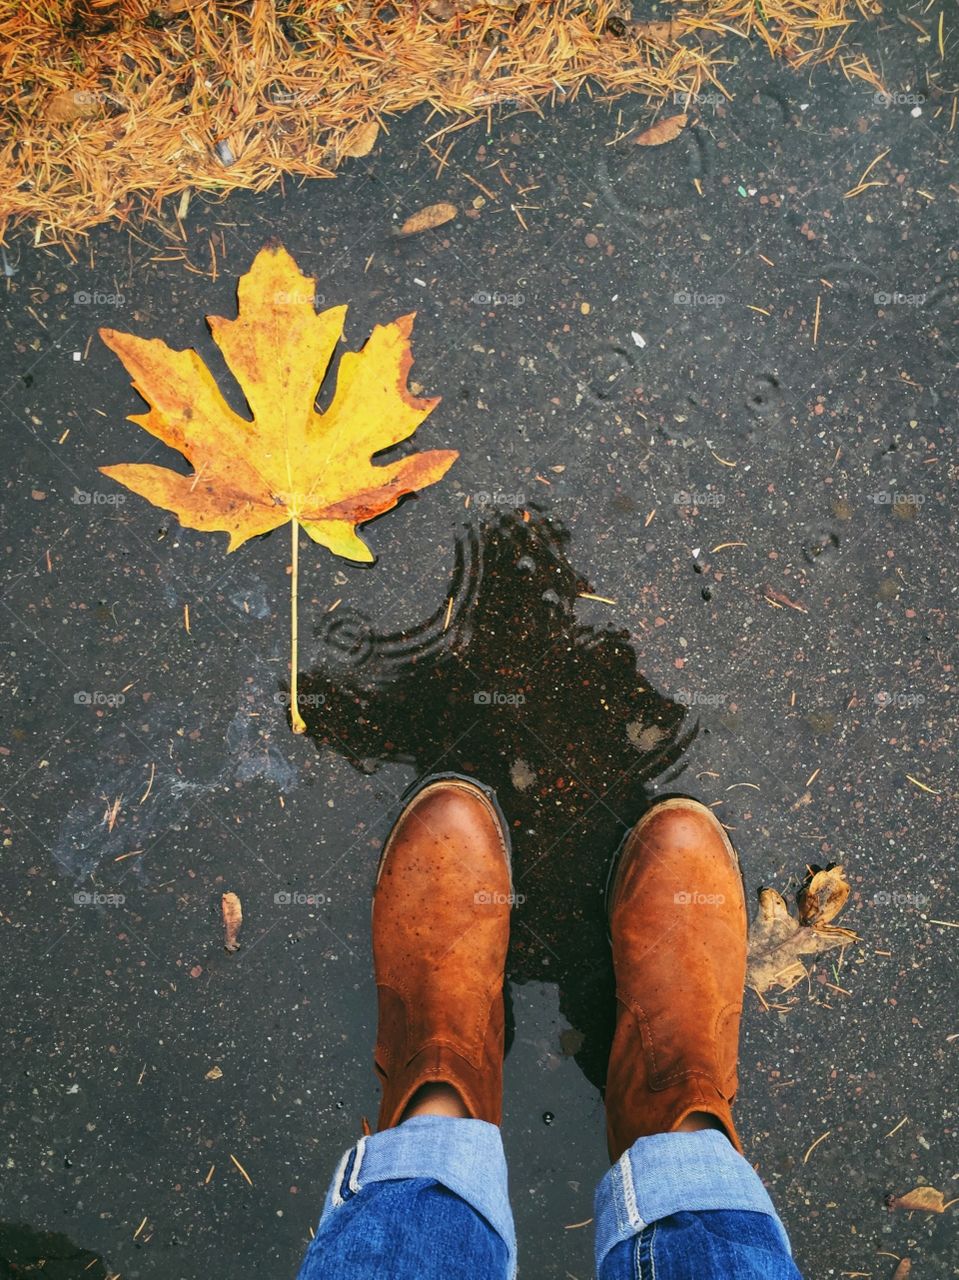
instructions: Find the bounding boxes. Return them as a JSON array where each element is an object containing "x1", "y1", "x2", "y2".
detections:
[{"x1": 300, "y1": 512, "x2": 697, "y2": 1085}]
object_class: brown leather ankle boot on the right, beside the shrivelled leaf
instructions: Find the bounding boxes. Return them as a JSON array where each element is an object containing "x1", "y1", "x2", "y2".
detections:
[{"x1": 606, "y1": 799, "x2": 746, "y2": 1161}]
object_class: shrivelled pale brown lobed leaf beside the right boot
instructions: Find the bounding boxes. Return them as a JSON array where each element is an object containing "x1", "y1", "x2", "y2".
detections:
[{"x1": 746, "y1": 867, "x2": 857, "y2": 996}]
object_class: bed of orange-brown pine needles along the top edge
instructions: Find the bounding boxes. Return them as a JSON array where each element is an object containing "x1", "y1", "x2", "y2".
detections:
[{"x1": 0, "y1": 0, "x2": 881, "y2": 244}]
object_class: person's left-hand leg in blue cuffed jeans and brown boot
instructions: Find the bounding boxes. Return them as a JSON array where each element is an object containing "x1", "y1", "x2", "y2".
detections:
[{"x1": 298, "y1": 778, "x2": 516, "y2": 1280}]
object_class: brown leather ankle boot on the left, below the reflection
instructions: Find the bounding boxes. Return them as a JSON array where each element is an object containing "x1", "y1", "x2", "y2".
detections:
[{"x1": 373, "y1": 778, "x2": 512, "y2": 1129}]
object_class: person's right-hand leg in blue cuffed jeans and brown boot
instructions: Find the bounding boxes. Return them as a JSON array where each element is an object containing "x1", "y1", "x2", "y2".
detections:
[{"x1": 595, "y1": 799, "x2": 799, "y2": 1280}]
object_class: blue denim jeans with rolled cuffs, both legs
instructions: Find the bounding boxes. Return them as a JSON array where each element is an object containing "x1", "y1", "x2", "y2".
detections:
[{"x1": 298, "y1": 1116, "x2": 800, "y2": 1280}]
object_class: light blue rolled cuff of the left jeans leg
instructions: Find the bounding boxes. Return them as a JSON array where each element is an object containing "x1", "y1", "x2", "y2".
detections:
[{"x1": 320, "y1": 1116, "x2": 516, "y2": 1280}]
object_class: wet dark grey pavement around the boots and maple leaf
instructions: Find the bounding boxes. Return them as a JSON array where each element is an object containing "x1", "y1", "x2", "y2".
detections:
[{"x1": 0, "y1": 10, "x2": 959, "y2": 1280}]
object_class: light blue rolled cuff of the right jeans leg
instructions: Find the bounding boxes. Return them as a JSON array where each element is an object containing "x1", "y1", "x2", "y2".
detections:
[{"x1": 595, "y1": 1129, "x2": 791, "y2": 1275}]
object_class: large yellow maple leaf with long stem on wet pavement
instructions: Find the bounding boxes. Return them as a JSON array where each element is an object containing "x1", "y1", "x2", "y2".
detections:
[{"x1": 100, "y1": 246, "x2": 458, "y2": 732}]
